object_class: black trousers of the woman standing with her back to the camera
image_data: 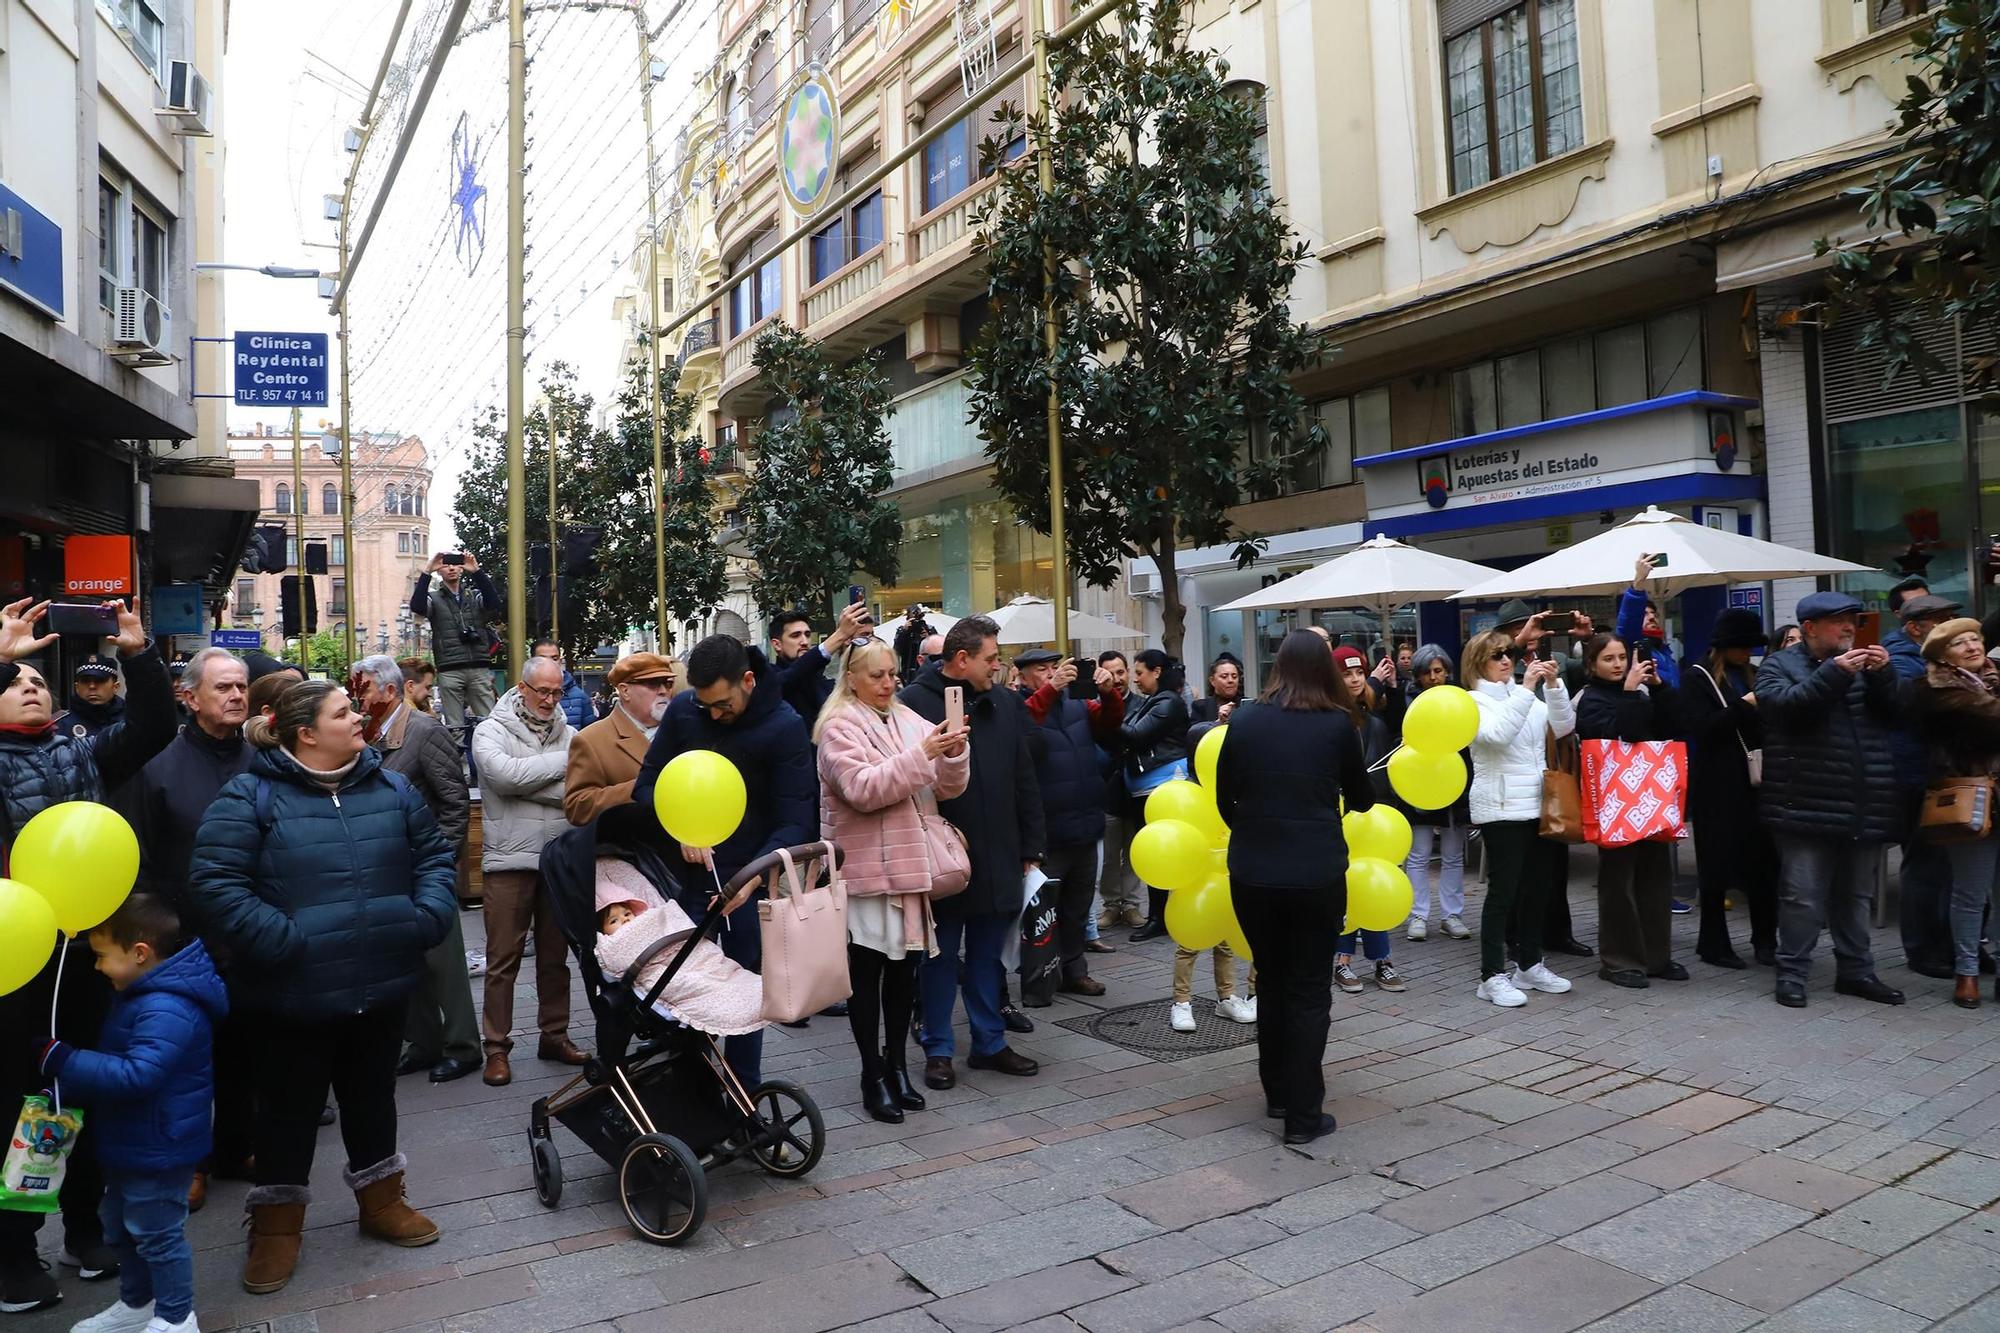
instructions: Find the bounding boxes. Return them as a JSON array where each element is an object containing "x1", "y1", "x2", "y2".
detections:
[{"x1": 1230, "y1": 879, "x2": 1348, "y2": 1133}]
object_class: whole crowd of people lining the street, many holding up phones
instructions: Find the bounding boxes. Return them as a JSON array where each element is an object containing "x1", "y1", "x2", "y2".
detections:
[{"x1": 0, "y1": 554, "x2": 2000, "y2": 1333}]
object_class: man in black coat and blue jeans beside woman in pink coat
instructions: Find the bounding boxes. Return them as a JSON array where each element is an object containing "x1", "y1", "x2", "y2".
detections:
[{"x1": 900, "y1": 616, "x2": 1046, "y2": 1089}]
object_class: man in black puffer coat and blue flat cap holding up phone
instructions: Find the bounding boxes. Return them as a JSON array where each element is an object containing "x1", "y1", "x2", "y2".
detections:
[{"x1": 1756, "y1": 592, "x2": 1904, "y2": 1009}]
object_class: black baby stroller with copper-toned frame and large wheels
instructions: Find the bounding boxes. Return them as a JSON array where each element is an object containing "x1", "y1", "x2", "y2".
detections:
[{"x1": 528, "y1": 805, "x2": 838, "y2": 1245}]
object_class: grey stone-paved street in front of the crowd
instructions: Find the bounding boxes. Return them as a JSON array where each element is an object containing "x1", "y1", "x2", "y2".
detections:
[{"x1": 23, "y1": 867, "x2": 2000, "y2": 1333}]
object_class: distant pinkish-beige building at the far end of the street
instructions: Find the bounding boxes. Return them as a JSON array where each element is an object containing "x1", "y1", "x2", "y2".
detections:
[{"x1": 228, "y1": 420, "x2": 434, "y2": 656}]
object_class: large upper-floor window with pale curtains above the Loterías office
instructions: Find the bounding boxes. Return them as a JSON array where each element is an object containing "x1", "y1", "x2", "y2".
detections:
[{"x1": 1438, "y1": 0, "x2": 1584, "y2": 192}]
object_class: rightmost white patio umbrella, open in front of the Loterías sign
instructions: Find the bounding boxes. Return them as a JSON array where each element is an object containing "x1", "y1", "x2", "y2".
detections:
[{"x1": 1454, "y1": 506, "x2": 1874, "y2": 600}]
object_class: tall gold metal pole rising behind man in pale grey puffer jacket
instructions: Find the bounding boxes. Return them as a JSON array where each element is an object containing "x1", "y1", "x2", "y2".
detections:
[{"x1": 504, "y1": 0, "x2": 528, "y2": 681}]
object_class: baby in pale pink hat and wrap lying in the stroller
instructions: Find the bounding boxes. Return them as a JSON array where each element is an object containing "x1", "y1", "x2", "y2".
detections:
[{"x1": 594, "y1": 857, "x2": 764, "y2": 1037}]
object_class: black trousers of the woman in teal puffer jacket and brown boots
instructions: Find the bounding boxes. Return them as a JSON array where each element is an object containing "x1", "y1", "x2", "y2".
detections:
[{"x1": 256, "y1": 1001, "x2": 404, "y2": 1187}]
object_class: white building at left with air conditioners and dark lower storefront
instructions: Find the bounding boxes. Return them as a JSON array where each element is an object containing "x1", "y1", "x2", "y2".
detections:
[{"x1": 0, "y1": 0, "x2": 254, "y2": 660}]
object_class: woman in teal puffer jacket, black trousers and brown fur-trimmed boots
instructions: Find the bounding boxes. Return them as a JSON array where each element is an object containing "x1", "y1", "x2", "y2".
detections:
[{"x1": 188, "y1": 681, "x2": 458, "y2": 1291}]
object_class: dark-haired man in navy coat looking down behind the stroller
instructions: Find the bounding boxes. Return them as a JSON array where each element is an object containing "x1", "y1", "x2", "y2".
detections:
[{"x1": 632, "y1": 634, "x2": 820, "y2": 1087}]
